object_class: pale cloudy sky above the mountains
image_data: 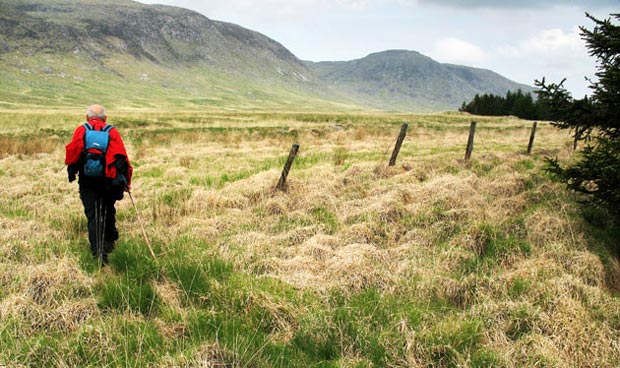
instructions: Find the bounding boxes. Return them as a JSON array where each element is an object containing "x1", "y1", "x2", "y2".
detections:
[{"x1": 140, "y1": 0, "x2": 620, "y2": 98}]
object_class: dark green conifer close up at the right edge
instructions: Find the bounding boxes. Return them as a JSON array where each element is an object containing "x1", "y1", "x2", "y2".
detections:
[{"x1": 536, "y1": 14, "x2": 620, "y2": 220}]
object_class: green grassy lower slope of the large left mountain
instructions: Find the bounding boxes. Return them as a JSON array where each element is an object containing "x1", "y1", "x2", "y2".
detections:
[{"x1": 0, "y1": 49, "x2": 358, "y2": 111}]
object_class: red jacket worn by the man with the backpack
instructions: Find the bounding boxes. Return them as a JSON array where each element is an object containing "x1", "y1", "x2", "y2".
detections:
[{"x1": 65, "y1": 118, "x2": 133, "y2": 187}]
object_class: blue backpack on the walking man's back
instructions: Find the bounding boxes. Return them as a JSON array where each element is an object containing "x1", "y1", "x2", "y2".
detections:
[{"x1": 82, "y1": 123, "x2": 114, "y2": 177}]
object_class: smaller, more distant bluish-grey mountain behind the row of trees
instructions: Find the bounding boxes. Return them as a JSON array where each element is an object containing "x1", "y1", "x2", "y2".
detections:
[{"x1": 305, "y1": 50, "x2": 533, "y2": 111}]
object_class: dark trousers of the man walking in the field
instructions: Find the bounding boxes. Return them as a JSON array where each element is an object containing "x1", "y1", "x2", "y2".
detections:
[{"x1": 80, "y1": 183, "x2": 118, "y2": 262}]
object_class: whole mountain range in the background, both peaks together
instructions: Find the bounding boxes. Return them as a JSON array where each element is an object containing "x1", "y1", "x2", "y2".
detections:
[{"x1": 0, "y1": 0, "x2": 531, "y2": 111}]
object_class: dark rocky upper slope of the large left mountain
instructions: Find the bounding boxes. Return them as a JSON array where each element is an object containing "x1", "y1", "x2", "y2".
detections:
[{"x1": 0, "y1": 0, "x2": 310, "y2": 80}]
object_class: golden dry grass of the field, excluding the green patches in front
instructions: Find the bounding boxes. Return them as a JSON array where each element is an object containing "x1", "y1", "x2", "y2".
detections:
[{"x1": 0, "y1": 112, "x2": 620, "y2": 367}]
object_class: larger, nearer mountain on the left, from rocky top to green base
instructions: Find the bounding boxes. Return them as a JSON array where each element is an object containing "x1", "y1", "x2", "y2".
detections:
[{"x1": 0, "y1": 0, "x2": 336, "y2": 108}]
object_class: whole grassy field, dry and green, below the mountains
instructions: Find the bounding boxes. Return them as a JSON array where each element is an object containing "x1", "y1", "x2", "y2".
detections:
[{"x1": 0, "y1": 110, "x2": 620, "y2": 367}]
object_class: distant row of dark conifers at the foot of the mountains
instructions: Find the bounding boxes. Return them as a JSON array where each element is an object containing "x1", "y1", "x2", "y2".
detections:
[{"x1": 459, "y1": 89, "x2": 553, "y2": 120}]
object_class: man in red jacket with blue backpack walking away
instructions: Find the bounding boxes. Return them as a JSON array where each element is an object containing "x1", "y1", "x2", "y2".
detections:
[{"x1": 65, "y1": 105, "x2": 133, "y2": 266}]
